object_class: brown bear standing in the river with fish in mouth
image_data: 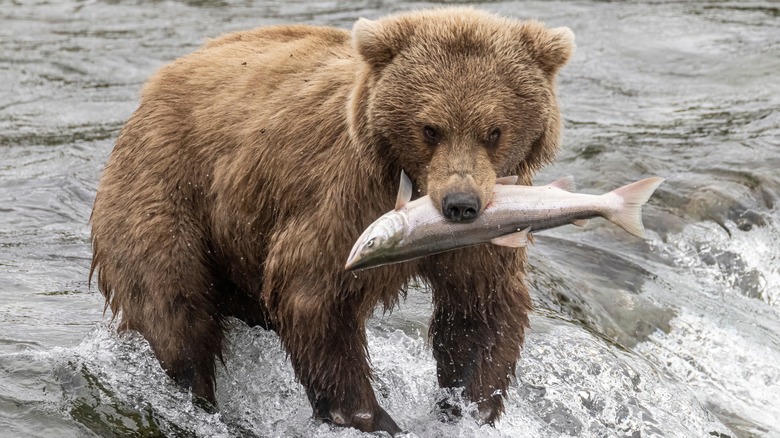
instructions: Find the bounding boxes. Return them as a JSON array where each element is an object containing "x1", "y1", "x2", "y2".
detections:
[{"x1": 90, "y1": 8, "x2": 574, "y2": 434}]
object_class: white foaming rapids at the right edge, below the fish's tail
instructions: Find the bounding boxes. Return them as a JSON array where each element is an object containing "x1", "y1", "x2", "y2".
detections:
[{"x1": 635, "y1": 219, "x2": 780, "y2": 437}]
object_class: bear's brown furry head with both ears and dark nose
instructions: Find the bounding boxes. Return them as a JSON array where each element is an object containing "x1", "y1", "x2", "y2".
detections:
[{"x1": 350, "y1": 8, "x2": 574, "y2": 221}]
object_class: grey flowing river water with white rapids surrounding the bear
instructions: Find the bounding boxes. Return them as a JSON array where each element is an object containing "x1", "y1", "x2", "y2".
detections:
[{"x1": 0, "y1": 0, "x2": 780, "y2": 437}]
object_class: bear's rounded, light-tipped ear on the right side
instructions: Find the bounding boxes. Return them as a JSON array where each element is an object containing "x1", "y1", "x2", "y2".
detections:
[{"x1": 522, "y1": 21, "x2": 574, "y2": 76}]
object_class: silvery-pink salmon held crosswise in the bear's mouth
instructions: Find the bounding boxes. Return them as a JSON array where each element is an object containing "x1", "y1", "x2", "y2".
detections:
[{"x1": 344, "y1": 171, "x2": 664, "y2": 271}]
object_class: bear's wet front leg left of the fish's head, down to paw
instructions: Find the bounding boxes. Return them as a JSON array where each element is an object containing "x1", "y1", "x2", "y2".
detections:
[{"x1": 275, "y1": 282, "x2": 401, "y2": 435}]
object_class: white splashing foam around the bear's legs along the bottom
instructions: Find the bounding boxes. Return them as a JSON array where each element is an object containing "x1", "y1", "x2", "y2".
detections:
[{"x1": 32, "y1": 310, "x2": 728, "y2": 438}]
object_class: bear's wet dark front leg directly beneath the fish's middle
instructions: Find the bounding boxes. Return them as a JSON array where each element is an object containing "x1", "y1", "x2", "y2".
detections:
[{"x1": 423, "y1": 246, "x2": 531, "y2": 424}]
